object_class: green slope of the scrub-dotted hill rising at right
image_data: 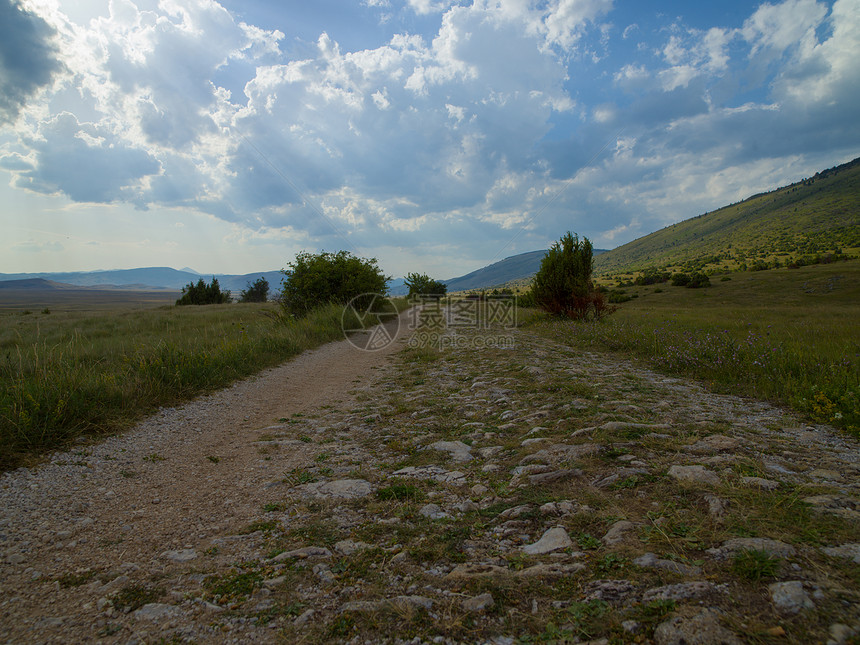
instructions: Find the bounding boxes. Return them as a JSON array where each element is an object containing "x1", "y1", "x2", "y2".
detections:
[{"x1": 594, "y1": 158, "x2": 860, "y2": 275}]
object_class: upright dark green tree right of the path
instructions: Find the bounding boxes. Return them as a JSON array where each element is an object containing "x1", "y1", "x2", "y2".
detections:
[{"x1": 532, "y1": 232, "x2": 614, "y2": 320}]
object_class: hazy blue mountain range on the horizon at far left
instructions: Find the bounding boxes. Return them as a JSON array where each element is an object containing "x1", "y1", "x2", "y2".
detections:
[{"x1": 0, "y1": 267, "x2": 284, "y2": 296}]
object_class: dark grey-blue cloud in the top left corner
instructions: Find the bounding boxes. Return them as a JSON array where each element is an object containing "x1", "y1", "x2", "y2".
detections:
[{"x1": 0, "y1": 0, "x2": 62, "y2": 123}]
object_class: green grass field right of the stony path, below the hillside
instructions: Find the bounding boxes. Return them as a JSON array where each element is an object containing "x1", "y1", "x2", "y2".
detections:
[{"x1": 530, "y1": 261, "x2": 860, "y2": 436}]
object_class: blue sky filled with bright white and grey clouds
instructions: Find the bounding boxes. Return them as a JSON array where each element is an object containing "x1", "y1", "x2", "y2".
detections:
[{"x1": 0, "y1": 0, "x2": 860, "y2": 279}]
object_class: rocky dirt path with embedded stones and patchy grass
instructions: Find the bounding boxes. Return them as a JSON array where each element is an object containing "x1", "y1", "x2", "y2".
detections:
[{"x1": 0, "y1": 320, "x2": 860, "y2": 644}]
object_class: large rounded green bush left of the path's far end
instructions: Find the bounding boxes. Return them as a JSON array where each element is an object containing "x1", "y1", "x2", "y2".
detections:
[{"x1": 280, "y1": 251, "x2": 389, "y2": 316}]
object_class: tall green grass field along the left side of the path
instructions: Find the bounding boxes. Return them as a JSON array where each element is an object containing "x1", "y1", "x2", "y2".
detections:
[{"x1": 0, "y1": 304, "x2": 359, "y2": 469}]
